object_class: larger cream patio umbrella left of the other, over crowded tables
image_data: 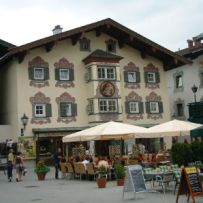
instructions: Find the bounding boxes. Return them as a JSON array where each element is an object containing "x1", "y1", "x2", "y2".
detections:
[{"x1": 63, "y1": 121, "x2": 147, "y2": 142}]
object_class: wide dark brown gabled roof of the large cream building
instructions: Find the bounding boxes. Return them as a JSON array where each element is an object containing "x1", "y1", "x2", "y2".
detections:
[{"x1": 0, "y1": 18, "x2": 190, "y2": 70}]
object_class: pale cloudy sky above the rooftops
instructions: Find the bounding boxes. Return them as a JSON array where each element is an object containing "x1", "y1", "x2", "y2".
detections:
[{"x1": 0, "y1": 0, "x2": 203, "y2": 51}]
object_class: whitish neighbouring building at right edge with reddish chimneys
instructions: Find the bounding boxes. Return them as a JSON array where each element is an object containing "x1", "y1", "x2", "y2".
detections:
[{"x1": 167, "y1": 34, "x2": 203, "y2": 136}]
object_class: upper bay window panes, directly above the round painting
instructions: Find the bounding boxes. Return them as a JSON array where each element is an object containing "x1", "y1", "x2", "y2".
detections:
[{"x1": 97, "y1": 67, "x2": 116, "y2": 80}]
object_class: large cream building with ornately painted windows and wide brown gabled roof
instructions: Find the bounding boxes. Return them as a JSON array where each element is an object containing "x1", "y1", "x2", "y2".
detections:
[{"x1": 0, "y1": 19, "x2": 189, "y2": 162}]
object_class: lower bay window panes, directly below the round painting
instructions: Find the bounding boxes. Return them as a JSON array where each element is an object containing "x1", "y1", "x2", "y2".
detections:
[{"x1": 99, "y1": 99, "x2": 117, "y2": 113}]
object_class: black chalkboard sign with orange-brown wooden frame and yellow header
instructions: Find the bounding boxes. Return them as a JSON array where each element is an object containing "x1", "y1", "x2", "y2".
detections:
[{"x1": 176, "y1": 167, "x2": 203, "y2": 203}]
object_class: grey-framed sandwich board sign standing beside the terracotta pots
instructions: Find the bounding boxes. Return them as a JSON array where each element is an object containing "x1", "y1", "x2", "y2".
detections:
[{"x1": 123, "y1": 165, "x2": 146, "y2": 199}]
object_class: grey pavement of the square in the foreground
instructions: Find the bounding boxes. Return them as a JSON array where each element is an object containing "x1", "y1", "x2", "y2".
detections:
[{"x1": 0, "y1": 168, "x2": 203, "y2": 203}]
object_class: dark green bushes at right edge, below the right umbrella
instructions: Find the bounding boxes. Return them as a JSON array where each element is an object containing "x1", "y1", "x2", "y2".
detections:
[{"x1": 171, "y1": 141, "x2": 203, "y2": 166}]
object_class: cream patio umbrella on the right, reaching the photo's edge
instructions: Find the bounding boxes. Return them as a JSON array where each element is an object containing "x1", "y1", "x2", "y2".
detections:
[{"x1": 140, "y1": 119, "x2": 202, "y2": 138}]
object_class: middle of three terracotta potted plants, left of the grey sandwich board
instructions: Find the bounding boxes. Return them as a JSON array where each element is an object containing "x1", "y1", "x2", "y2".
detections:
[{"x1": 97, "y1": 160, "x2": 109, "y2": 188}]
